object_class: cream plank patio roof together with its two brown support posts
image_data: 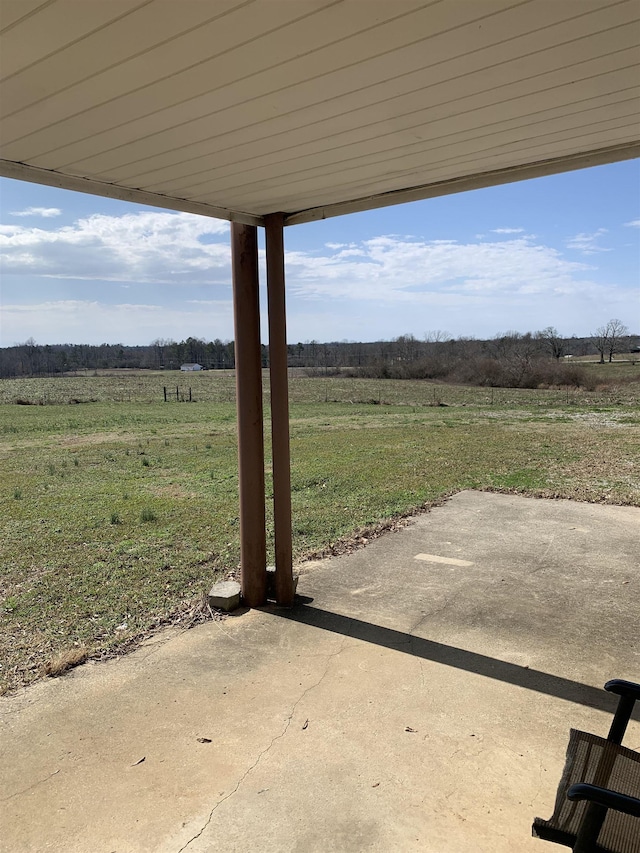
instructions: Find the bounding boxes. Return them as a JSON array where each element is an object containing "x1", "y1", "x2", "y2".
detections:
[{"x1": 0, "y1": 0, "x2": 640, "y2": 606}]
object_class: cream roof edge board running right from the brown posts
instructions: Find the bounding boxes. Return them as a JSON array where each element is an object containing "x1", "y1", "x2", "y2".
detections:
[{"x1": 284, "y1": 141, "x2": 640, "y2": 225}]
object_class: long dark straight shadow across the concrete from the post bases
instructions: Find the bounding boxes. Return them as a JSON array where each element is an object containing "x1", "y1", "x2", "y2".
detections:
[{"x1": 268, "y1": 604, "x2": 640, "y2": 721}]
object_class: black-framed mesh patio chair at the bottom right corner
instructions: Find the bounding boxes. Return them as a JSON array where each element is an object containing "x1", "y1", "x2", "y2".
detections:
[{"x1": 533, "y1": 679, "x2": 640, "y2": 853}]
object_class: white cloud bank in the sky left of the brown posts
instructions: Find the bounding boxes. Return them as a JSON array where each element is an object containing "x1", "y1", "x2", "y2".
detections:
[{"x1": 0, "y1": 212, "x2": 230, "y2": 284}]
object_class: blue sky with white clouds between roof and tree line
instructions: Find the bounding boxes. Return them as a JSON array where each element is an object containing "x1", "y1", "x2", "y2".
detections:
[{"x1": 0, "y1": 160, "x2": 640, "y2": 346}]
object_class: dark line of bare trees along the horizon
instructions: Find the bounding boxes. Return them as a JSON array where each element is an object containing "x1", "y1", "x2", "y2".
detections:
[{"x1": 0, "y1": 319, "x2": 638, "y2": 386}]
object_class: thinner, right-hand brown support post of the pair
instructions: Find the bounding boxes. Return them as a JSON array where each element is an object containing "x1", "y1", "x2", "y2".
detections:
[{"x1": 265, "y1": 213, "x2": 295, "y2": 607}]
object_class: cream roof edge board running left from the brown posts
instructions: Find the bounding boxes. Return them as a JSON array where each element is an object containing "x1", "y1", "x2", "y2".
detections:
[{"x1": 0, "y1": 160, "x2": 264, "y2": 225}]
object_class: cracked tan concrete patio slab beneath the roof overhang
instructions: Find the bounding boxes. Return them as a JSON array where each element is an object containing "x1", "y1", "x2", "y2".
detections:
[{"x1": 0, "y1": 492, "x2": 640, "y2": 853}]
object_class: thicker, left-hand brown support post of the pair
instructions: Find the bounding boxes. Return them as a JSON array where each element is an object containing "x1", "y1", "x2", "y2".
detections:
[{"x1": 231, "y1": 222, "x2": 267, "y2": 607}]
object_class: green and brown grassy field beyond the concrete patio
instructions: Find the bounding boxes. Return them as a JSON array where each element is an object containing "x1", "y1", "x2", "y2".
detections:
[{"x1": 0, "y1": 364, "x2": 640, "y2": 689}]
